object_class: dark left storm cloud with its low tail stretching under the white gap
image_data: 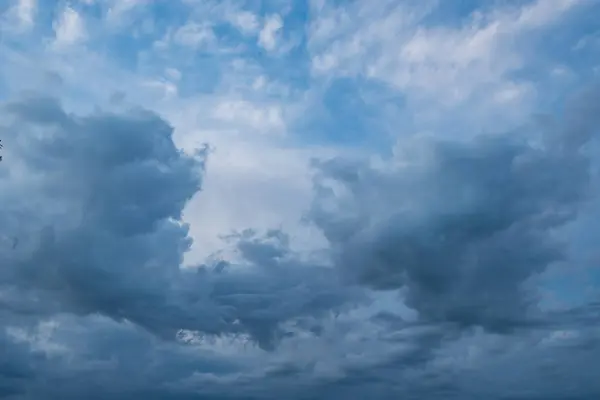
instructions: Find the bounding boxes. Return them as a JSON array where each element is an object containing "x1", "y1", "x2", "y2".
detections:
[{"x1": 0, "y1": 98, "x2": 356, "y2": 348}]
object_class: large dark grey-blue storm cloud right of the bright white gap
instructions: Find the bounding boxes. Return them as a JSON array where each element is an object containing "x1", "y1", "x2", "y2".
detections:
[{"x1": 312, "y1": 87, "x2": 600, "y2": 331}]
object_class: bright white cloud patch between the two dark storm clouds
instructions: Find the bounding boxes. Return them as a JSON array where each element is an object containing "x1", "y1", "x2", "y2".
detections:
[{"x1": 164, "y1": 94, "x2": 330, "y2": 264}]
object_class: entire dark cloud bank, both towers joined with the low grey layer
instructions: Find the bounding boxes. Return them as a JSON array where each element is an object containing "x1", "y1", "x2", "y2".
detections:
[{"x1": 0, "y1": 89, "x2": 600, "y2": 399}]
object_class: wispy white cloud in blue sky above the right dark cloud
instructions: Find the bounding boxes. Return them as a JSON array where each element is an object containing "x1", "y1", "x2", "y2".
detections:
[{"x1": 309, "y1": 0, "x2": 583, "y2": 128}]
